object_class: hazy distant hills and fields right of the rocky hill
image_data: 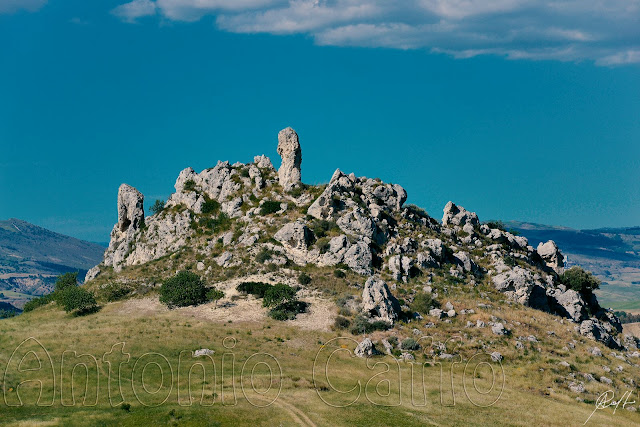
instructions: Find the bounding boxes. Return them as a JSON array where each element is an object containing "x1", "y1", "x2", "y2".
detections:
[{"x1": 505, "y1": 221, "x2": 640, "y2": 312}]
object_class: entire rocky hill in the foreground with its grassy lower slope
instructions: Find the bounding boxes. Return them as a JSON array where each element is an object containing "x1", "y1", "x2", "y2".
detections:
[{"x1": 6, "y1": 128, "x2": 640, "y2": 426}]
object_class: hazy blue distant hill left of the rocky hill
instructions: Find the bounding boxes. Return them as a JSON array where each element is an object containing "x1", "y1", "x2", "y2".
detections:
[{"x1": 0, "y1": 218, "x2": 105, "y2": 307}]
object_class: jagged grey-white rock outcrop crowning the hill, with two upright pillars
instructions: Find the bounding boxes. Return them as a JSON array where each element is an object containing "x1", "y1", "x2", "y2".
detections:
[{"x1": 87, "y1": 128, "x2": 624, "y2": 348}]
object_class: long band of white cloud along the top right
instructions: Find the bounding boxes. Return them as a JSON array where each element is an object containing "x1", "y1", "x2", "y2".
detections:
[{"x1": 111, "y1": 0, "x2": 640, "y2": 66}]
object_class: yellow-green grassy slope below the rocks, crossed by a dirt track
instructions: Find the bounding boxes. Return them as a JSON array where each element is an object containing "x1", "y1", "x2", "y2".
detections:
[{"x1": 0, "y1": 269, "x2": 640, "y2": 426}]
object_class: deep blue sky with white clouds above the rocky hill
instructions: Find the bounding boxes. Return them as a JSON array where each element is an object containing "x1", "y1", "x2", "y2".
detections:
[{"x1": 0, "y1": 0, "x2": 640, "y2": 242}]
